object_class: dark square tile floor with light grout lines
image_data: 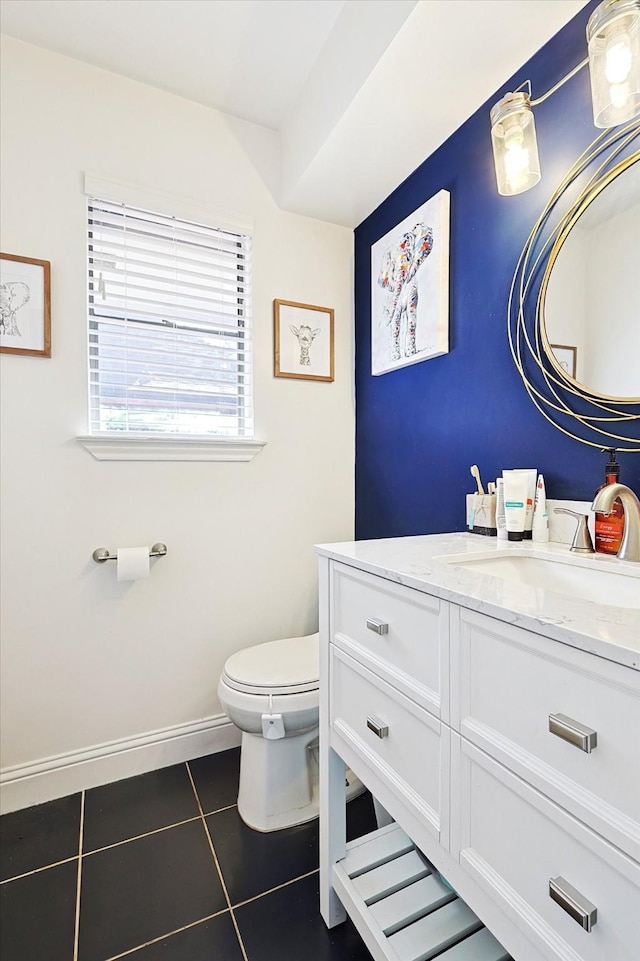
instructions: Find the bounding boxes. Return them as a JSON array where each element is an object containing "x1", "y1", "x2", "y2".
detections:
[{"x1": 0, "y1": 749, "x2": 376, "y2": 961}]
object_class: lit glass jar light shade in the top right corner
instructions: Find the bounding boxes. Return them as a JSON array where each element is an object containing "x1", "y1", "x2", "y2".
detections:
[{"x1": 587, "y1": 0, "x2": 640, "y2": 127}]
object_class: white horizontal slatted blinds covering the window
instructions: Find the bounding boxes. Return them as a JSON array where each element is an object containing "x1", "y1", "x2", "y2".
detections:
[{"x1": 88, "y1": 197, "x2": 253, "y2": 437}]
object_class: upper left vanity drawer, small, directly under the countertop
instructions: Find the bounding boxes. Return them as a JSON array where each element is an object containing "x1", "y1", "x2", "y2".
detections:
[{"x1": 331, "y1": 564, "x2": 448, "y2": 720}]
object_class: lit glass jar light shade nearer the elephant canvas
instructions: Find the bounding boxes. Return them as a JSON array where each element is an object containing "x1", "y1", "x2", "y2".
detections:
[{"x1": 491, "y1": 91, "x2": 540, "y2": 197}]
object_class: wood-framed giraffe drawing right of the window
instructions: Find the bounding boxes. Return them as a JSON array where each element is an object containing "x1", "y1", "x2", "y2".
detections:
[{"x1": 273, "y1": 300, "x2": 334, "y2": 381}]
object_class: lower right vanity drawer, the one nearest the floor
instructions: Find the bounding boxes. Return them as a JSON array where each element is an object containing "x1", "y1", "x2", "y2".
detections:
[{"x1": 451, "y1": 734, "x2": 640, "y2": 961}]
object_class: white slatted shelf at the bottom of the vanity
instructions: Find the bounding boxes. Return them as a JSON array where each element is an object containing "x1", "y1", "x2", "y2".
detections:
[{"x1": 333, "y1": 824, "x2": 510, "y2": 961}]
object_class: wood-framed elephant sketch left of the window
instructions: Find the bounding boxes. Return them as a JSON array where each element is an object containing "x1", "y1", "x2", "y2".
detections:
[{"x1": 0, "y1": 253, "x2": 51, "y2": 357}]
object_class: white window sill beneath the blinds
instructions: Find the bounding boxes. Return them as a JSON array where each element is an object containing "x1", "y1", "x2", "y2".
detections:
[{"x1": 76, "y1": 433, "x2": 266, "y2": 462}]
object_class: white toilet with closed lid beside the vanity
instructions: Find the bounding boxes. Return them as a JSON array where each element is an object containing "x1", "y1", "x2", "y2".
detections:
[{"x1": 218, "y1": 634, "x2": 364, "y2": 831}]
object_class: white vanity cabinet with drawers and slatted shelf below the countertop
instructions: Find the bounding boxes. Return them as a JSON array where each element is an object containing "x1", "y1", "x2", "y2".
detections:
[{"x1": 320, "y1": 539, "x2": 640, "y2": 961}]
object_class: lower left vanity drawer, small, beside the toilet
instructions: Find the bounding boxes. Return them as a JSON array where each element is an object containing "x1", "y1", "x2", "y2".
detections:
[{"x1": 330, "y1": 645, "x2": 449, "y2": 844}]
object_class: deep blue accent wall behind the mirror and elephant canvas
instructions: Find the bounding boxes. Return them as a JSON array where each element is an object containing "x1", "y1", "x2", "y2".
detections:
[{"x1": 355, "y1": 2, "x2": 640, "y2": 539}]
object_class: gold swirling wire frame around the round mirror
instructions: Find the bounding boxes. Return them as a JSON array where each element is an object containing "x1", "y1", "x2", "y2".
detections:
[{"x1": 507, "y1": 119, "x2": 640, "y2": 453}]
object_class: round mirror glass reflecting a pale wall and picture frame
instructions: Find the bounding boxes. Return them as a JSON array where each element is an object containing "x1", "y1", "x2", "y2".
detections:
[{"x1": 541, "y1": 151, "x2": 640, "y2": 403}]
